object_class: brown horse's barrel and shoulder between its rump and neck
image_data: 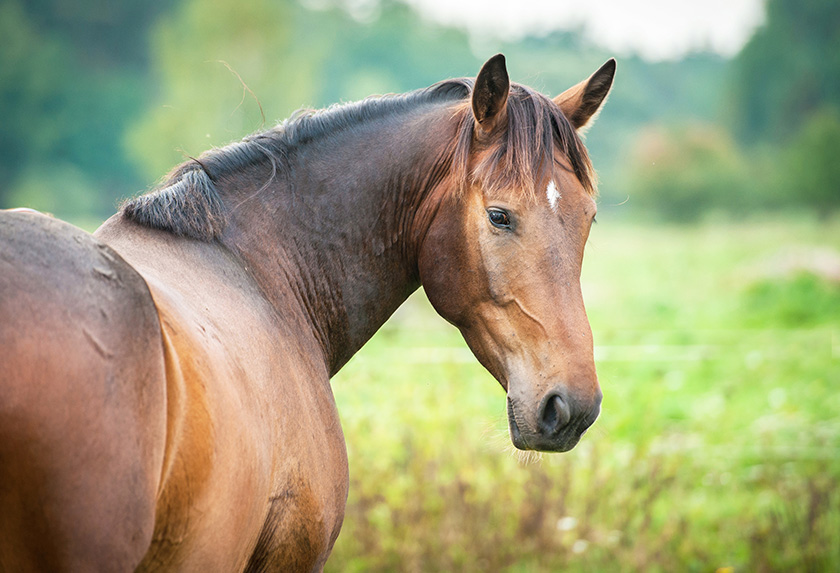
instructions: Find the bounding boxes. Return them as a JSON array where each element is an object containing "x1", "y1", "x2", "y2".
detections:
[{"x1": 97, "y1": 221, "x2": 348, "y2": 571}]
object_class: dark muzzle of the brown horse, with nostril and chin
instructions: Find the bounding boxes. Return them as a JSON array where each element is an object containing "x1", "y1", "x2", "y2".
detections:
[{"x1": 507, "y1": 386, "x2": 601, "y2": 452}]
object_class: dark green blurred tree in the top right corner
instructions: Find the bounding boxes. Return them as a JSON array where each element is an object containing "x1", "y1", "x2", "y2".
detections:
[{"x1": 731, "y1": 0, "x2": 840, "y2": 142}]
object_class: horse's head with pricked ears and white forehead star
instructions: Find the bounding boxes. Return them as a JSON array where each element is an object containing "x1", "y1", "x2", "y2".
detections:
[{"x1": 418, "y1": 55, "x2": 615, "y2": 451}]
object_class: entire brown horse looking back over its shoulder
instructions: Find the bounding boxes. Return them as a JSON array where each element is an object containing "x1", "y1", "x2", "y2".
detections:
[{"x1": 0, "y1": 55, "x2": 615, "y2": 571}]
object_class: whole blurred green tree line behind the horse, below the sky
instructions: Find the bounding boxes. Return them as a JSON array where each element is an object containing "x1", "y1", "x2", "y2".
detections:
[{"x1": 0, "y1": 0, "x2": 840, "y2": 220}]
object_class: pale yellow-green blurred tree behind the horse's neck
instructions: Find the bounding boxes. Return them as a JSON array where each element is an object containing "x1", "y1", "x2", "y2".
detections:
[{"x1": 125, "y1": 0, "x2": 328, "y2": 180}]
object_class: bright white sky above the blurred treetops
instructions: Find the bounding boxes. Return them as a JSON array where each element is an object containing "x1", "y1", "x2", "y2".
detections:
[{"x1": 400, "y1": 0, "x2": 764, "y2": 60}]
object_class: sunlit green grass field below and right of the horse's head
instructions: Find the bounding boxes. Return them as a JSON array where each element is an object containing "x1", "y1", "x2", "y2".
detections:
[{"x1": 327, "y1": 220, "x2": 840, "y2": 572}]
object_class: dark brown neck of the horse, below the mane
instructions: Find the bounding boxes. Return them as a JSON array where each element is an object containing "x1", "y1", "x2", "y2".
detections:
[{"x1": 223, "y1": 106, "x2": 454, "y2": 375}]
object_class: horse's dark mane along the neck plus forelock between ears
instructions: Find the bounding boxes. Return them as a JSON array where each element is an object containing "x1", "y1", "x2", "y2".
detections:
[{"x1": 120, "y1": 78, "x2": 595, "y2": 241}]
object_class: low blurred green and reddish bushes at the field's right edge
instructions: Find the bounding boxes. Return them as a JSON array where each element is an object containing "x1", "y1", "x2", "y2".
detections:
[{"x1": 626, "y1": 102, "x2": 840, "y2": 223}]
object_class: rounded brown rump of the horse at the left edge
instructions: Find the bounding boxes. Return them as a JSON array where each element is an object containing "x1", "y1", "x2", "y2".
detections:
[{"x1": 0, "y1": 212, "x2": 166, "y2": 571}]
